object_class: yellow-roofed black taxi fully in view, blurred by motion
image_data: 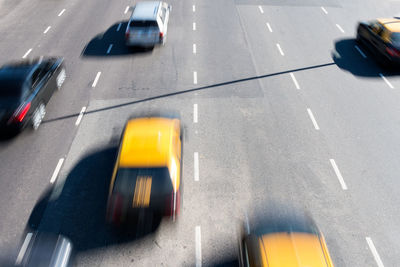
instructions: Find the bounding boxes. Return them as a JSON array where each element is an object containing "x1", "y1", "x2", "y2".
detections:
[{"x1": 107, "y1": 117, "x2": 182, "y2": 225}]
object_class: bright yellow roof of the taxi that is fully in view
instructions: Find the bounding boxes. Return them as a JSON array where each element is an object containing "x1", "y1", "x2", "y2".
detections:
[{"x1": 119, "y1": 118, "x2": 177, "y2": 168}]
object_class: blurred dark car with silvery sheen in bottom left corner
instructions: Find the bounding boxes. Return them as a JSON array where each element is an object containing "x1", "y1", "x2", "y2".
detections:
[{"x1": 15, "y1": 232, "x2": 73, "y2": 267}]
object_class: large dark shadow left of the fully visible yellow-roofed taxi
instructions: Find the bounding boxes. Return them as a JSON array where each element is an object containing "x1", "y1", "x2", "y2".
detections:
[{"x1": 27, "y1": 147, "x2": 161, "y2": 253}]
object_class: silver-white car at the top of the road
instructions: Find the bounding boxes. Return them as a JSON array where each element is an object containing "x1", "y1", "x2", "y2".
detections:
[{"x1": 125, "y1": 1, "x2": 171, "y2": 47}]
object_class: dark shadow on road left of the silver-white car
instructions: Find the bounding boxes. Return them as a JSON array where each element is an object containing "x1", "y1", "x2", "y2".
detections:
[{"x1": 81, "y1": 21, "x2": 152, "y2": 57}]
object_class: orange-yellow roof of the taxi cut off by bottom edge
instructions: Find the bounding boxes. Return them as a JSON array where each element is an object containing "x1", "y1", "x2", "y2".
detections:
[{"x1": 259, "y1": 232, "x2": 331, "y2": 267}]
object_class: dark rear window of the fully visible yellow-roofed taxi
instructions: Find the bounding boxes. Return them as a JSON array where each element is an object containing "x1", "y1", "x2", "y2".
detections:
[{"x1": 113, "y1": 167, "x2": 170, "y2": 196}]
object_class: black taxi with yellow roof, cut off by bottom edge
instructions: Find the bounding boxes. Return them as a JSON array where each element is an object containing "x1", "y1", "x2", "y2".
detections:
[{"x1": 239, "y1": 217, "x2": 333, "y2": 267}]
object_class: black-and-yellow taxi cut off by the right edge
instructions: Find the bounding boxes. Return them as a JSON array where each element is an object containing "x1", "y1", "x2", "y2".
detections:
[{"x1": 357, "y1": 18, "x2": 400, "y2": 65}]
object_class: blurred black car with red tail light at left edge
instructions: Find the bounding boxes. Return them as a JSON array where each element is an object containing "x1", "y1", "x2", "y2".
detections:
[{"x1": 0, "y1": 58, "x2": 66, "y2": 133}]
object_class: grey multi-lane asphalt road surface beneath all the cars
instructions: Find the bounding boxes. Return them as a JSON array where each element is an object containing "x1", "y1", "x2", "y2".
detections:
[{"x1": 0, "y1": 0, "x2": 400, "y2": 266}]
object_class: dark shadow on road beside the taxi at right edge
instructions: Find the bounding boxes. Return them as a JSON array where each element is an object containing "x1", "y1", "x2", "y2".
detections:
[{"x1": 332, "y1": 39, "x2": 400, "y2": 78}]
